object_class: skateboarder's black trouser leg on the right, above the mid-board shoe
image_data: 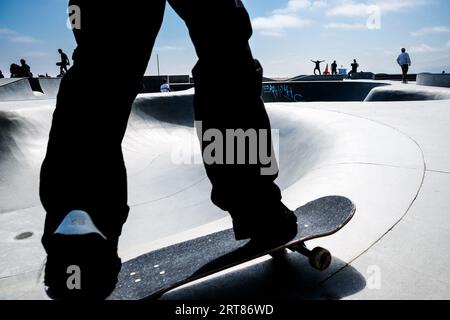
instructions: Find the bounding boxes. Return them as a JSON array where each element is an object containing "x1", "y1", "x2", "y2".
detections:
[{"x1": 168, "y1": 0, "x2": 298, "y2": 238}]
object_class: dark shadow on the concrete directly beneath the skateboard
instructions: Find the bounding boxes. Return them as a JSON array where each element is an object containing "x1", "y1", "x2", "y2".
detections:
[{"x1": 162, "y1": 253, "x2": 366, "y2": 300}]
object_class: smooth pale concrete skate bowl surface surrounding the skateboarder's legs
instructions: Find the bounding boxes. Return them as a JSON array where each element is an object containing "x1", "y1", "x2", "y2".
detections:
[{"x1": 0, "y1": 80, "x2": 450, "y2": 300}]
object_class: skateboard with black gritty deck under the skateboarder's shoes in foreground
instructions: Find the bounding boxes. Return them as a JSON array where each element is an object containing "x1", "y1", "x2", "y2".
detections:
[{"x1": 109, "y1": 196, "x2": 356, "y2": 300}]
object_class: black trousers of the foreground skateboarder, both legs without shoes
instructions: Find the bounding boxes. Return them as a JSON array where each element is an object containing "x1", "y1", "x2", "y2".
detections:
[{"x1": 40, "y1": 0, "x2": 281, "y2": 245}]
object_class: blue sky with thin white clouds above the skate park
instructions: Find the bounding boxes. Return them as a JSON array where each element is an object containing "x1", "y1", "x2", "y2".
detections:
[{"x1": 0, "y1": 0, "x2": 450, "y2": 77}]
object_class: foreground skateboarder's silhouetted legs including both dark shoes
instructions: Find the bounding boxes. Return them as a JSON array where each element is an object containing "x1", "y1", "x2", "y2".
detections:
[{"x1": 40, "y1": 0, "x2": 297, "y2": 299}]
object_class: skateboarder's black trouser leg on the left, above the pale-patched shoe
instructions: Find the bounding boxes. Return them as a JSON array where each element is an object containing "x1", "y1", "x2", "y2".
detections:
[{"x1": 40, "y1": 0, "x2": 165, "y2": 246}]
